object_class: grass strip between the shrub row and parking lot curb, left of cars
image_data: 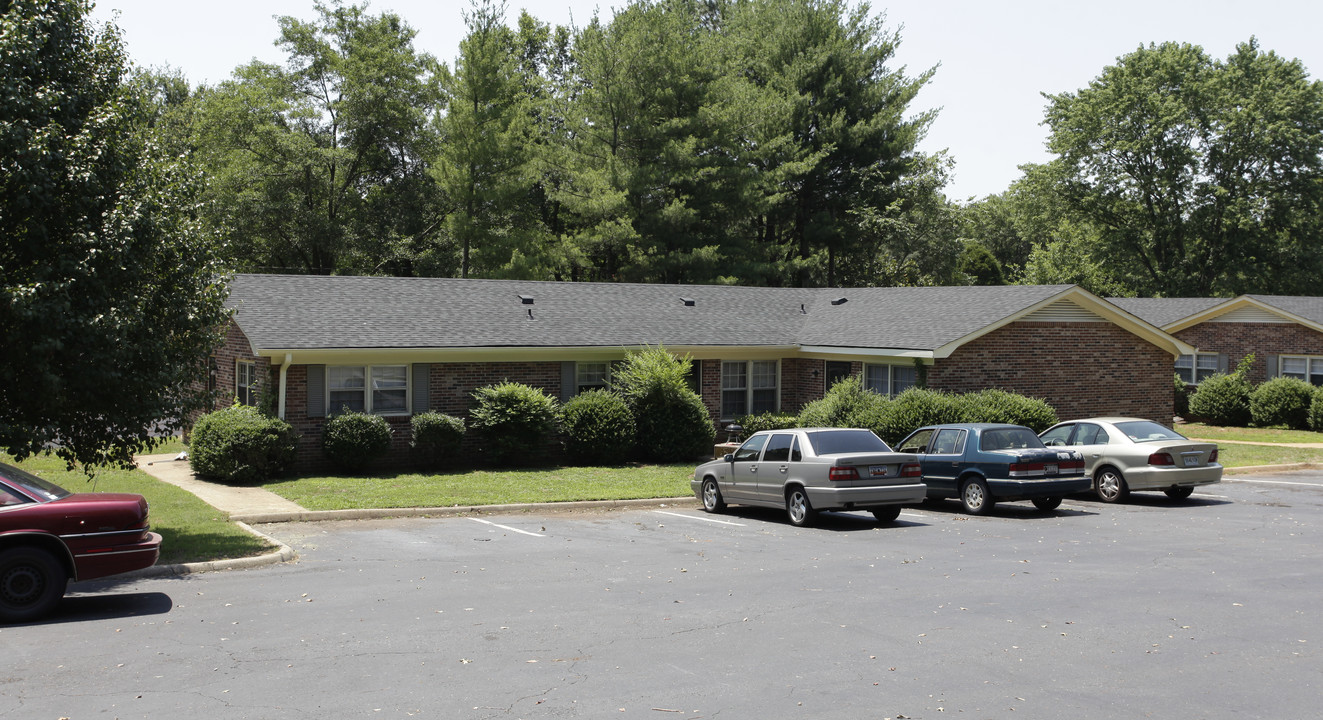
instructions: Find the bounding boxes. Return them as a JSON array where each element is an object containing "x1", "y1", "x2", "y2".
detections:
[{"x1": 263, "y1": 463, "x2": 693, "y2": 510}]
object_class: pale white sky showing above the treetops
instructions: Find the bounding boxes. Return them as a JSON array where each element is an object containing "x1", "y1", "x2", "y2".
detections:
[{"x1": 93, "y1": 0, "x2": 1323, "y2": 200}]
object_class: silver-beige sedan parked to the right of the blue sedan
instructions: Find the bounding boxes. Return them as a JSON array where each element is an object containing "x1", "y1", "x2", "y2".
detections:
[{"x1": 1039, "y1": 417, "x2": 1222, "y2": 503}]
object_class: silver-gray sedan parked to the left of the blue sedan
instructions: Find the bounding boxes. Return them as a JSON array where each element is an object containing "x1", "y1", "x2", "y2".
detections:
[{"x1": 689, "y1": 428, "x2": 927, "y2": 527}]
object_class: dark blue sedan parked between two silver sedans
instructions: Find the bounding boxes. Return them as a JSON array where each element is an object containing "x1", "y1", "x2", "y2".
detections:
[{"x1": 900, "y1": 422, "x2": 1093, "y2": 515}]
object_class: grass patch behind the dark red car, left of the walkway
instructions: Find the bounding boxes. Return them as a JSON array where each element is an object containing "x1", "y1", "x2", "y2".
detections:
[{"x1": 0, "y1": 455, "x2": 271, "y2": 565}]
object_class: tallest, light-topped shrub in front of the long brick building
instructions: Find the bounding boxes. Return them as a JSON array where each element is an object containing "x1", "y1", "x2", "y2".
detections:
[{"x1": 611, "y1": 347, "x2": 716, "y2": 462}]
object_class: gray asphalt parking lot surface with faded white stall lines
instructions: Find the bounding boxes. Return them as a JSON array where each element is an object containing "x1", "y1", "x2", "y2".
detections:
[{"x1": 0, "y1": 471, "x2": 1323, "y2": 720}]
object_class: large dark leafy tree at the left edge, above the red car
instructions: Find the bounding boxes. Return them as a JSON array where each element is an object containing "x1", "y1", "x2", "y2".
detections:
[{"x1": 0, "y1": 0, "x2": 226, "y2": 466}]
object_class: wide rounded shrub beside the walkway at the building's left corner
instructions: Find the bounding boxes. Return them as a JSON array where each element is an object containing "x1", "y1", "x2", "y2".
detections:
[{"x1": 188, "y1": 405, "x2": 299, "y2": 484}]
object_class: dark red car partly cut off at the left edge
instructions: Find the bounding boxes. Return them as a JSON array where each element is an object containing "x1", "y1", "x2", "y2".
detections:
[{"x1": 0, "y1": 463, "x2": 161, "y2": 622}]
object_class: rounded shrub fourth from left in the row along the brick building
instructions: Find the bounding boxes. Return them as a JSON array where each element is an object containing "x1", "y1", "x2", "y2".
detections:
[{"x1": 468, "y1": 380, "x2": 558, "y2": 465}]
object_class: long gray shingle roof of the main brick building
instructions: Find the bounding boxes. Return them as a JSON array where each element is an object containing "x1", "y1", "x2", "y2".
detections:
[{"x1": 229, "y1": 275, "x2": 1072, "y2": 349}]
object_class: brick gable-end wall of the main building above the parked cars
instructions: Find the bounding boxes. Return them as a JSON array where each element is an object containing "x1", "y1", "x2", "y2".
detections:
[{"x1": 927, "y1": 323, "x2": 1175, "y2": 425}]
